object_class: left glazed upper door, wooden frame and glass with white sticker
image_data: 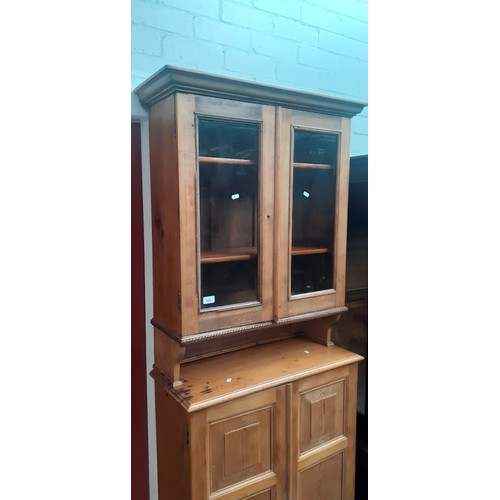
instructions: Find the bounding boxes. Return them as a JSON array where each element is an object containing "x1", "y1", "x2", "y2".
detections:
[{"x1": 176, "y1": 94, "x2": 275, "y2": 335}]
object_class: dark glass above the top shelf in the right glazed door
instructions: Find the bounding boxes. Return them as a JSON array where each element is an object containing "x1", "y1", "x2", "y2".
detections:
[{"x1": 293, "y1": 130, "x2": 337, "y2": 165}]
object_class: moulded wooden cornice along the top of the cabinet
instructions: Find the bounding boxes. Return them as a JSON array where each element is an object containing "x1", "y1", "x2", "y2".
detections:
[{"x1": 134, "y1": 66, "x2": 367, "y2": 118}]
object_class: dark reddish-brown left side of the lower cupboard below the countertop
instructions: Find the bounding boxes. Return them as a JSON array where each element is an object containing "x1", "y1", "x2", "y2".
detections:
[{"x1": 155, "y1": 383, "x2": 191, "y2": 500}]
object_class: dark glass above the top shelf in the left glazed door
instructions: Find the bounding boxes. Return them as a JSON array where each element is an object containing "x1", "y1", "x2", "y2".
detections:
[{"x1": 198, "y1": 120, "x2": 258, "y2": 160}]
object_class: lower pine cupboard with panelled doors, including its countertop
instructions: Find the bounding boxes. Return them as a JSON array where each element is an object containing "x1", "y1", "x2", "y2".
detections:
[{"x1": 151, "y1": 339, "x2": 362, "y2": 500}]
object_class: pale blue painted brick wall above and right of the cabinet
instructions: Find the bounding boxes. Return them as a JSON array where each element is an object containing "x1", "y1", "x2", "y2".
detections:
[{"x1": 131, "y1": 0, "x2": 368, "y2": 156}]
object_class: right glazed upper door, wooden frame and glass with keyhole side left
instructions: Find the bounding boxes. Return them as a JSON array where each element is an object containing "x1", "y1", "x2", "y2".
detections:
[{"x1": 274, "y1": 108, "x2": 350, "y2": 319}]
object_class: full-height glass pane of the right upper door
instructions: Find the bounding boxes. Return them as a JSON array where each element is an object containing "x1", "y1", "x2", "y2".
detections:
[{"x1": 290, "y1": 130, "x2": 337, "y2": 295}]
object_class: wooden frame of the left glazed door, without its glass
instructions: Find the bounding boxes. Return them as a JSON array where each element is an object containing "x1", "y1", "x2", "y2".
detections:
[{"x1": 176, "y1": 94, "x2": 275, "y2": 336}]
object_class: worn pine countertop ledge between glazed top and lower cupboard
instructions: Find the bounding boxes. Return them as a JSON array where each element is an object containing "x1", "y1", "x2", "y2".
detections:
[{"x1": 151, "y1": 337, "x2": 363, "y2": 412}]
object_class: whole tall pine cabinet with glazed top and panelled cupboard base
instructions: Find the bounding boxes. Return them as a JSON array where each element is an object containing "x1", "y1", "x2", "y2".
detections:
[{"x1": 136, "y1": 66, "x2": 365, "y2": 500}]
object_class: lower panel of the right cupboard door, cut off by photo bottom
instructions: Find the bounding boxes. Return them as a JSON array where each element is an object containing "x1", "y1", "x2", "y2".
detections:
[{"x1": 299, "y1": 452, "x2": 344, "y2": 500}]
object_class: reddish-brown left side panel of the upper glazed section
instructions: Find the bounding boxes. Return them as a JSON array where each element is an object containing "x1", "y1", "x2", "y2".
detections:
[{"x1": 149, "y1": 96, "x2": 181, "y2": 333}]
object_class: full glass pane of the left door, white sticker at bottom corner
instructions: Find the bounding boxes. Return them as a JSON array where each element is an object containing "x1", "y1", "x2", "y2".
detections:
[{"x1": 198, "y1": 119, "x2": 260, "y2": 310}]
